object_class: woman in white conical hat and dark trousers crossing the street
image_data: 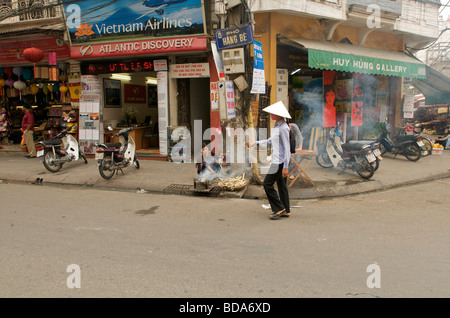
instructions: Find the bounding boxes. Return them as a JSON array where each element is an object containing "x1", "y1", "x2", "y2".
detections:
[{"x1": 249, "y1": 102, "x2": 291, "y2": 220}]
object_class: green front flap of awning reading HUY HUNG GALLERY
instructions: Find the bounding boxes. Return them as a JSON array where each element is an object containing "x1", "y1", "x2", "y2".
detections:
[{"x1": 308, "y1": 49, "x2": 426, "y2": 78}]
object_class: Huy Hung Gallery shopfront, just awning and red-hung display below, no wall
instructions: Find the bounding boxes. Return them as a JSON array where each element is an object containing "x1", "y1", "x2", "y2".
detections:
[{"x1": 277, "y1": 38, "x2": 425, "y2": 146}]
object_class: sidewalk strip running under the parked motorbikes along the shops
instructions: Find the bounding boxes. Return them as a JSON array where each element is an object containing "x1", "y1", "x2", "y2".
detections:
[{"x1": 0, "y1": 145, "x2": 450, "y2": 199}]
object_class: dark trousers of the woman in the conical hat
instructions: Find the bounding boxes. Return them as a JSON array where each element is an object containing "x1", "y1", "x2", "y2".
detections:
[{"x1": 263, "y1": 164, "x2": 290, "y2": 213}]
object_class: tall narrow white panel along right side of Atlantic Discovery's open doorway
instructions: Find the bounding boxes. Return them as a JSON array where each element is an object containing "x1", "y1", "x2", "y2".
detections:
[{"x1": 157, "y1": 72, "x2": 169, "y2": 155}]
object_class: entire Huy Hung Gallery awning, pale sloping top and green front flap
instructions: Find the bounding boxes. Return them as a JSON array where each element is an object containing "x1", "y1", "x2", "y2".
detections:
[{"x1": 281, "y1": 38, "x2": 426, "y2": 78}]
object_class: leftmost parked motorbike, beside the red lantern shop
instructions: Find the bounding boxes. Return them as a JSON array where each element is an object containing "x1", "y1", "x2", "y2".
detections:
[{"x1": 36, "y1": 129, "x2": 88, "y2": 173}]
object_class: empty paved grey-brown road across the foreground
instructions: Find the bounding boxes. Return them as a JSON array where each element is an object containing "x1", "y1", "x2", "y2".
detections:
[{"x1": 0, "y1": 179, "x2": 450, "y2": 298}]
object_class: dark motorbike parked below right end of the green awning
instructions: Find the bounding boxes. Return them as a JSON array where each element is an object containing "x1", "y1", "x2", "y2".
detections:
[{"x1": 377, "y1": 122, "x2": 426, "y2": 161}]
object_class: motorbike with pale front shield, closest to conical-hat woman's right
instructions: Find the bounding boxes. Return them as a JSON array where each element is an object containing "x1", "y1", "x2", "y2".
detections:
[{"x1": 316, "y1": 124, "x2": 377, "y2": 179}]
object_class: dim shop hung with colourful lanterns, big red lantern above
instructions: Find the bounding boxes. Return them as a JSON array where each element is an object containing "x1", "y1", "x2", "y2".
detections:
[{"x1": 0, "y1": 36, "x2": 71, "y2": 144}]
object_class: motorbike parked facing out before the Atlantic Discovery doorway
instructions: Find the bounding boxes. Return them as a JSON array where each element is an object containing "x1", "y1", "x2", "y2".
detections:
[{"x1": 95, "y1": 127, "x2": 140, "y2": 180}]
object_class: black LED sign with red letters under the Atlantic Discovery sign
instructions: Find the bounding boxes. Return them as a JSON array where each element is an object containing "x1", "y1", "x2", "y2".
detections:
[{"x1": 82, "y1": 60, "x2": 153, "y2": 74}]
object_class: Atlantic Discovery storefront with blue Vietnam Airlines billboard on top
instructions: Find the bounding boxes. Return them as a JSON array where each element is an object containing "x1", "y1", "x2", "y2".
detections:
[{"x1": 65, "y1": 0, "x2": 210, "y2": 155}]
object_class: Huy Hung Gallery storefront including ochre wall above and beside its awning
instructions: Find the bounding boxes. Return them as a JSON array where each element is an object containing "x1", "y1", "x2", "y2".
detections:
[{"x1": 255, "y1": 13, "x2": 426, "y2": 148}]
